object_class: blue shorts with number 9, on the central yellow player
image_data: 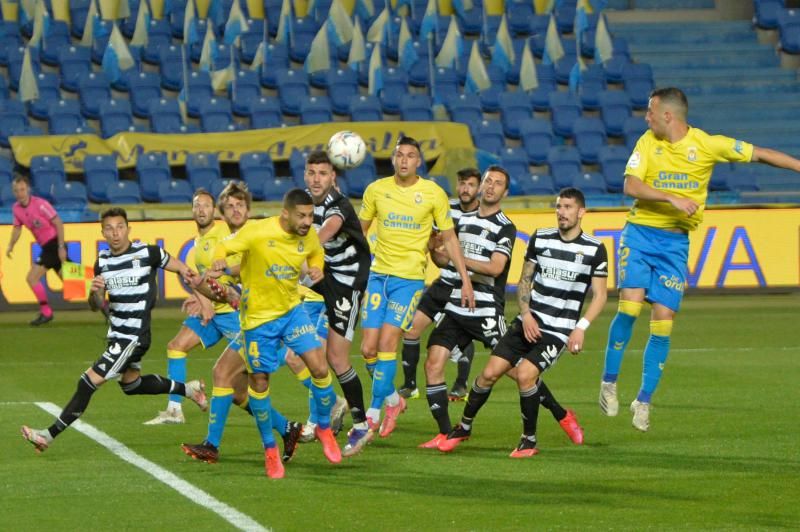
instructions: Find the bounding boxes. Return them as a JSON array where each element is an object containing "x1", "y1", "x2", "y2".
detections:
[{"x1": 361, "y1": 272, "x2": 425, "y2": 331}]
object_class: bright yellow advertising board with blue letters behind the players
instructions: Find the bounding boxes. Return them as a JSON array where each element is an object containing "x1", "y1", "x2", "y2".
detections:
[{"x1": 0, "y1": 209, "x2": 800, "y2": 304}]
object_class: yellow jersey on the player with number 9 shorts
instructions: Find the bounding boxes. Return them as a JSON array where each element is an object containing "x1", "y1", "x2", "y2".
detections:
[{"x1": 358, "y1": 176, "x2": 453, "y2": 279}]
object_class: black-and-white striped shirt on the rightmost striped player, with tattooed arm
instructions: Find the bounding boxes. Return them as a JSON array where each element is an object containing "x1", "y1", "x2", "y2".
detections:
[{"x1": 525, "y1": 228, "x2": 608, "y2": 342}]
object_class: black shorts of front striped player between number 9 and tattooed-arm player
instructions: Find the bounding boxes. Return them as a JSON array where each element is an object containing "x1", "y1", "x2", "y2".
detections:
[{"x1": 428, "y1": 310, "x2": 506, "y2": 351}]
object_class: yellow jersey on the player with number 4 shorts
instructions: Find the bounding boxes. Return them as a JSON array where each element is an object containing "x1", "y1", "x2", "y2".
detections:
[{"x1": 214, "y1": 216, "x2": 325, "y2": 330}]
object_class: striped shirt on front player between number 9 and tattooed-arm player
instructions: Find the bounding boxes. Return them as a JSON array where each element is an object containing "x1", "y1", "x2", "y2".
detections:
[{"x1": 445, "y1": 211, "x2": 517, "y2": 317}]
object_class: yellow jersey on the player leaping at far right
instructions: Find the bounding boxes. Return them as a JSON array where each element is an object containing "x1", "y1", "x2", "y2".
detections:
[{"x1": 625, "y1": 127, "x2": 753, "y2": 231}]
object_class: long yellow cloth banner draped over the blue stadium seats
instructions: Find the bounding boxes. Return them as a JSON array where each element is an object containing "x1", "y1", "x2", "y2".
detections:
[{"x1": 11, "y1": 122, "x2": 474, "y2": 172}]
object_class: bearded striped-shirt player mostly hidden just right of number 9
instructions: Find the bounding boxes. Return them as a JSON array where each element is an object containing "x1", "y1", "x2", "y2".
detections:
[{"x1": 397, "y1": 168, "x2": 481, "y2": 400}]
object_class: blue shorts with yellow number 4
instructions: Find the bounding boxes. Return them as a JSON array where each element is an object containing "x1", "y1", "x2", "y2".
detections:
[{"x1": 244, "y1": 305, "x2": 322, "y2": 373}]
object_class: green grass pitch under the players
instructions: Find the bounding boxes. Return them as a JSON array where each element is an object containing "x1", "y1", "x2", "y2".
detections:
[{"x1": 0, "y1": 294, "x2": 800, "y2": 531}]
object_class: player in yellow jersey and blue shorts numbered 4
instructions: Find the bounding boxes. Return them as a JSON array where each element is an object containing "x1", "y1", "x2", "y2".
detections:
[{"x1": 213, "y1": 189, "x2": 341, "y2": 478}]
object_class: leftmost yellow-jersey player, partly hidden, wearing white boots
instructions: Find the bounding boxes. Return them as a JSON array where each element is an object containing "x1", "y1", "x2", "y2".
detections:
[{"x1": 145, "y1": 189, "x2": 247, "y2": 425}]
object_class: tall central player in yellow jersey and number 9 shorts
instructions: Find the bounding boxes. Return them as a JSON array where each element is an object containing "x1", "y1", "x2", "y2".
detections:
[{"x1": 358, "y1": 137, "x2": 475, "y2": 438}]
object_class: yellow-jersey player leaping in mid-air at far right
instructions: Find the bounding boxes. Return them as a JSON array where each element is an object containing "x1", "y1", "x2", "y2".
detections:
[{"x1": 600, "y1": 88, "x2": 800, "y2": 431}]
